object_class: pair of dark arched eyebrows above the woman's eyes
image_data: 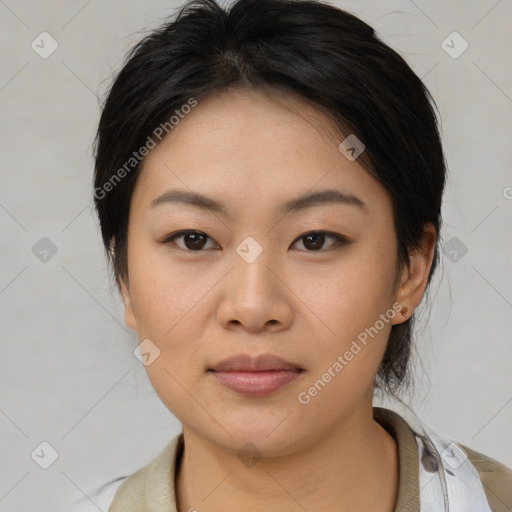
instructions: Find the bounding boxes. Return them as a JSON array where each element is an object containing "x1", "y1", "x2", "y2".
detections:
[{"x1": 150, "y1": 189, "x2": 368, "y2": 217}]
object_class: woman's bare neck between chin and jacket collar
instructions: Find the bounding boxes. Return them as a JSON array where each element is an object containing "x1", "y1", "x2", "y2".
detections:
[{"x1": 175, "y1": 409, "x2": 398, "y2": 512}]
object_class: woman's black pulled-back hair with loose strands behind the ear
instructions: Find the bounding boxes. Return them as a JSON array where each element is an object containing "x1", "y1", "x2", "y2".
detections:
[{"x1": 94, "y1": 0, "x2": 446, "y2": 396}]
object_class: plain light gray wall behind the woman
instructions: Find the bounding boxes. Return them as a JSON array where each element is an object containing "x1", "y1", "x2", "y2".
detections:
[{"x1": 0, "y1": 0, "x2": 512, "y2": 512}]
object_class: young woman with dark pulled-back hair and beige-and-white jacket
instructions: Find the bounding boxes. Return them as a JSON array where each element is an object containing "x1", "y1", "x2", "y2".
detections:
[{"x1": 82, "y1": 0, "x2": 512, "y2": 512}]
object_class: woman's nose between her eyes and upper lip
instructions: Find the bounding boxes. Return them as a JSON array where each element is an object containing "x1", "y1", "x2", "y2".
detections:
[{"x1": 217, "y1": 242, "x2": 293, "y2": 332}]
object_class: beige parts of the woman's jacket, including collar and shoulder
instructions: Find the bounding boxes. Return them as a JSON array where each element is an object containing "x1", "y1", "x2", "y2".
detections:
[{"x1": 109, "y1": 407, "x2": 512, "y2": 512}]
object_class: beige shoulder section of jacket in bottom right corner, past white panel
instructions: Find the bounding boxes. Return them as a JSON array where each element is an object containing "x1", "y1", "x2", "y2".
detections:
[{"x1": 457, "y1": 443, "x2": 512, "y2": 512}]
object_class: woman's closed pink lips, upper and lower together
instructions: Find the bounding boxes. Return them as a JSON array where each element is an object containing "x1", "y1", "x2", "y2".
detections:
[{"x1": 208, "y1": 354, "x2": 304, "y2": 397}]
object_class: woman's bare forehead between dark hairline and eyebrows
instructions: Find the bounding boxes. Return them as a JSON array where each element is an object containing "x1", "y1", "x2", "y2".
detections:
[{"x1": 133, "y1": 89, "x2": 390, "y2": 218}]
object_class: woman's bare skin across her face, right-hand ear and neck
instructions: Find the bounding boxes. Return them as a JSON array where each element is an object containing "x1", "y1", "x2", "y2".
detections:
[{"x1": 122, "y1": 89, "x2": 436, "y2": 512}]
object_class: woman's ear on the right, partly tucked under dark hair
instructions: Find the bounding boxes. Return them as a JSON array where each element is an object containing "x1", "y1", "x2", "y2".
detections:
[{"x1": 392, "y1": 222, "x2": 437, "y2": 324}]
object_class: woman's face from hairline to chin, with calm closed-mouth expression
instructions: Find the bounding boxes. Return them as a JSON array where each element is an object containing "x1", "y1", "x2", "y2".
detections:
[{"x1": 122, "y1": 90, "x2": 421, "y2": 455}]
